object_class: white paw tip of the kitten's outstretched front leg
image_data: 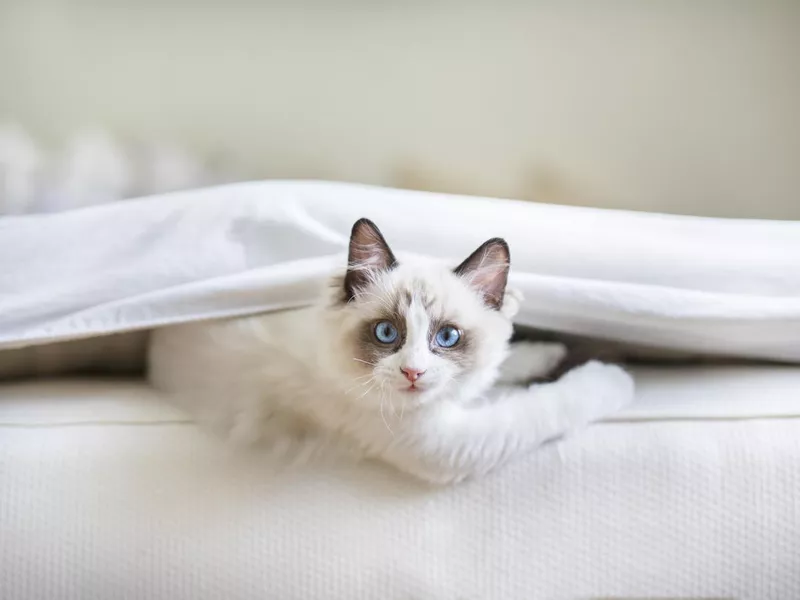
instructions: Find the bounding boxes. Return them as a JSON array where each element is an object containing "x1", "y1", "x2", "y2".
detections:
[{"x1": 559, "y1": 361, "x2": 634, "y2": 423}]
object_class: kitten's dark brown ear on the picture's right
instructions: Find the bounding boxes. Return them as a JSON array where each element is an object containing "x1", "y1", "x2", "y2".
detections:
[{"x1": 455, "y1": 238, "x2": 511, "y2": 310}]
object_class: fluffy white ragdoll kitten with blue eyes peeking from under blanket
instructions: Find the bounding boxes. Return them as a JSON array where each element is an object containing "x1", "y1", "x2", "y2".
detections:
[{"x1": 149, "y1": 219, "x2": 633, "y2": 483}]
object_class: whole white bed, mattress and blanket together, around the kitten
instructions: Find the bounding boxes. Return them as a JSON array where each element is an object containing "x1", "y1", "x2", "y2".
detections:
[{"x1": 0, "y1": 182, "x2": 800, "y2": 600}]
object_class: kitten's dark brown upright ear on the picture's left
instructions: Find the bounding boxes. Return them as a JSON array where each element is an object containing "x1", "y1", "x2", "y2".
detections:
[{"x1": 344, "y1": 219, "x2": 397, "y2": 300}]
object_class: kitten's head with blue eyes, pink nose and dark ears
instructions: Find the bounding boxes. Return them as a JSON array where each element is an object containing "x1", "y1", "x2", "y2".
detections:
[{"x1": 326, "y1": 219, "x2": 518, "y2": 406}]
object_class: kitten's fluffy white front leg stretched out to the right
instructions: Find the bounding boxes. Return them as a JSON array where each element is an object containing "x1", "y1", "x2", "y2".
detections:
[{"x1": 384, "y1": 362, "x2": 634, "y2": 483}]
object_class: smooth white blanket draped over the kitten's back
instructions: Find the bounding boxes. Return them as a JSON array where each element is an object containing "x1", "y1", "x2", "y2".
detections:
[{"x1": 0, "y1": 182, "x2": 800, "y2": 361}]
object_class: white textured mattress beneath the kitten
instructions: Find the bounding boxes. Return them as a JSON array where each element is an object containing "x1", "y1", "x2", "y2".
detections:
[{"x1": 0, "y1": 366, "x2": 800, "y2": 600}]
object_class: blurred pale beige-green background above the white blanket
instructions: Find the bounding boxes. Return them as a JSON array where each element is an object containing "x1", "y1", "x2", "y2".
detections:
[{"x1": 0, "y1": 0, "x2": 800, "y2": 219}]
